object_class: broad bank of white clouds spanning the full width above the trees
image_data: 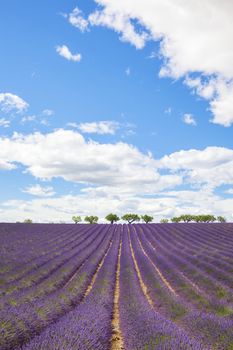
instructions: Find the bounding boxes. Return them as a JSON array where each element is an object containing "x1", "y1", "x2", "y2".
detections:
[{"x1": 0, "y1": 129, "x2": 233, "y2": 221}]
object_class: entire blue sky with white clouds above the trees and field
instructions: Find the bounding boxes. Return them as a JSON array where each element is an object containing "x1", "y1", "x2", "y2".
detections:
[{"x1": 0, "y1": 0, "x2": 233, "y2": 221}]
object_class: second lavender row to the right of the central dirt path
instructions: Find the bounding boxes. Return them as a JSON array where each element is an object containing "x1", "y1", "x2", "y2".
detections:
[{"x1": 134, "y1": 226, "x2": 233, "y2": 349}]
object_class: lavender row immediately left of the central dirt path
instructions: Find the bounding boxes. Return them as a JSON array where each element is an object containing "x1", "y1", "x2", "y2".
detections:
[{"x1": 22, "y1": 229, "x2": 120, "y2": 350}]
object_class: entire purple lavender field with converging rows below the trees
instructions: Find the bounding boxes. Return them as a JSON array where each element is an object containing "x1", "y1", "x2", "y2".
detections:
[{"x1": 0, "y1": 223, "x2": 233, "y2": 350}]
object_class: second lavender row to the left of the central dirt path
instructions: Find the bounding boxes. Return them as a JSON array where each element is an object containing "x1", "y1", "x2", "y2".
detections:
[{"x1": 0, "y1": 227, "x2": 113, "y2": 350}]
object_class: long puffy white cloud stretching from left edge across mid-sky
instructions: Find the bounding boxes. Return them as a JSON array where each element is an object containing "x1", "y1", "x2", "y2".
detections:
[{"x1": 0, "y1": 129, "x2": 181, "y2": 193}]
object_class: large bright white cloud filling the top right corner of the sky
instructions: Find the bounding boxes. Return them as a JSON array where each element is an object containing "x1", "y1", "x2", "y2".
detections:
[{"x1": 73, "y1": 0, "x2": 233, "y2": 126}]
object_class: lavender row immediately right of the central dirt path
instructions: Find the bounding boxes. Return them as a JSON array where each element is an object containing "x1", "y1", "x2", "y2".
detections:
[{"x1": 120, "y1": 226, "x2": 204, "y2": 350}]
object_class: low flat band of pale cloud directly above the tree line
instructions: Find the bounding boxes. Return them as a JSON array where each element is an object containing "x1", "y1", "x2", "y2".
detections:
[{"x1": 0, "y1": 186, "x2": 233, "y2": 222}]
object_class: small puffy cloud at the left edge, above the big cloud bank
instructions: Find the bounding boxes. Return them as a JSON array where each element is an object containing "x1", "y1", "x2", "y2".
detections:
[{"x1": 0, "y1": 92, "x2": 29, "y2": 113}]
